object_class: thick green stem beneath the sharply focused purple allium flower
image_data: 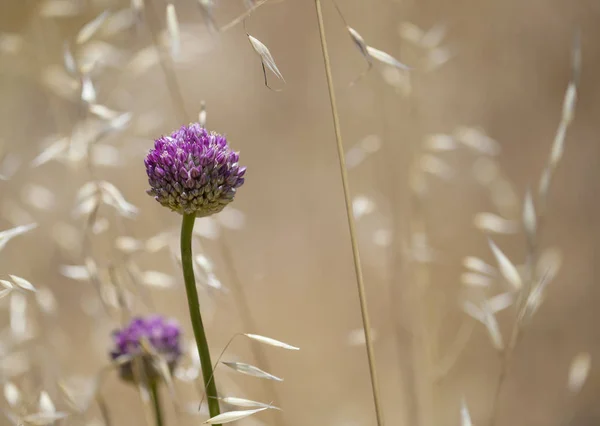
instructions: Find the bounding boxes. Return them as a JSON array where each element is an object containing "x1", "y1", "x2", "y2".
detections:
[{"x1": 181, "y1": 214, "x2": 220, "y2": 426}]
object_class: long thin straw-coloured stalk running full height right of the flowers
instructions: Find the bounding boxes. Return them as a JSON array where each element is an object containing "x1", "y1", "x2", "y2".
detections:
[{"x1": 315, "y1": 0, "x2": 383, "y2": 426}]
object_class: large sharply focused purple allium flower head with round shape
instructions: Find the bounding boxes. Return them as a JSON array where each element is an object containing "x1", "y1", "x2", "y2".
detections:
[{"x1": 144, "y1": 123, "x2": 246, "y2": 217}]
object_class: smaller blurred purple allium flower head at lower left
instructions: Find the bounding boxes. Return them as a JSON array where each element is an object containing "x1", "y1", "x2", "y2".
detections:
[{"x1": 110, "y1": 315, "x2": 182, "y2": 381}]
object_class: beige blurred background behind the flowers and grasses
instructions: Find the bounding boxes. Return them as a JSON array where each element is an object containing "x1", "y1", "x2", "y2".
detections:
[{"x1": 0, "y1": 0, "x2": 600, "y2": 426}]
